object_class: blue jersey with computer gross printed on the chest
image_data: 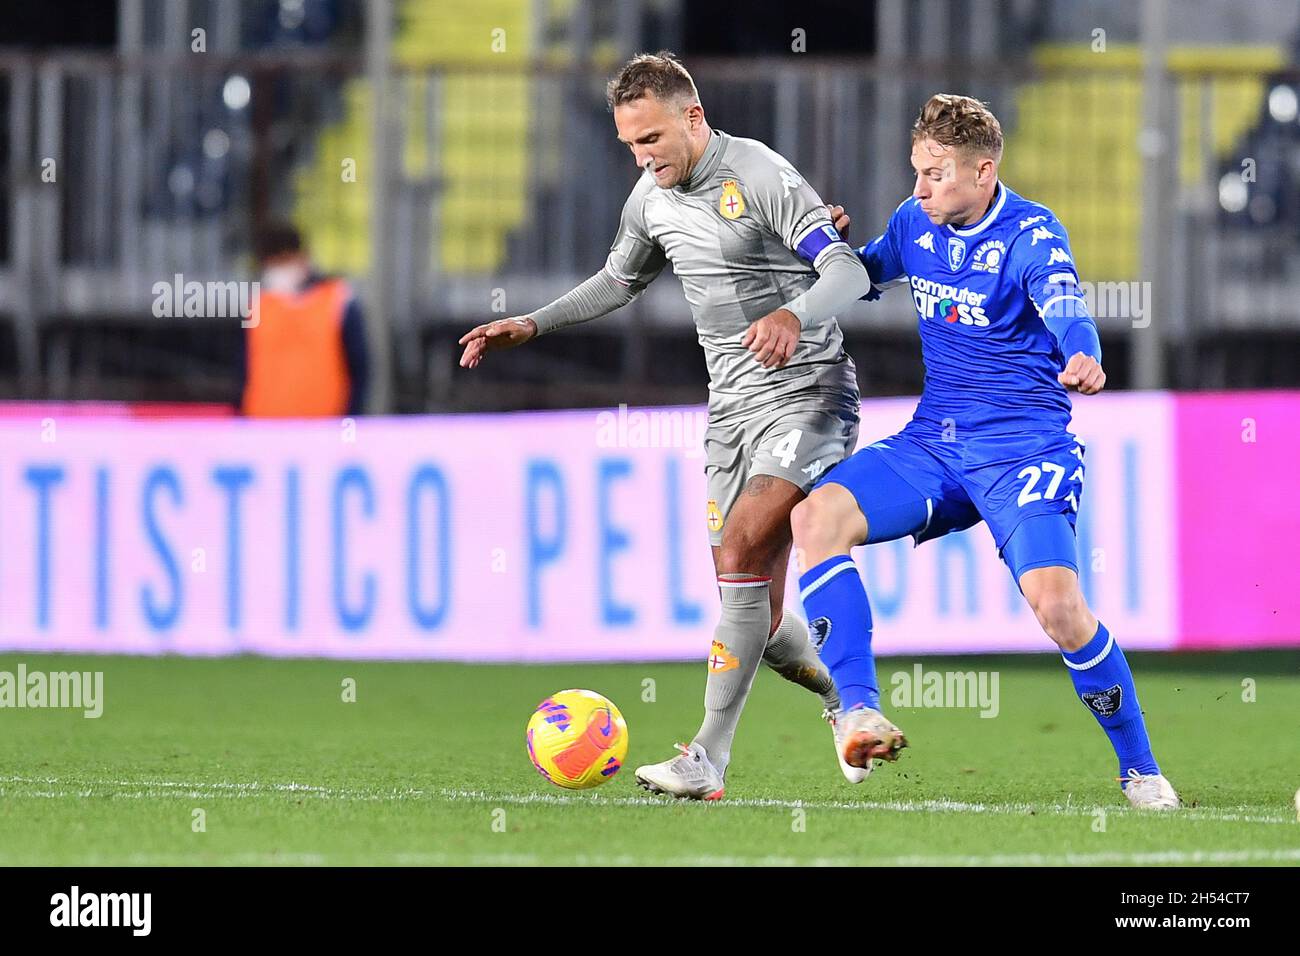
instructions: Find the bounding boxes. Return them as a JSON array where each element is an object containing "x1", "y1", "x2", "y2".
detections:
[{"x1": 858, "y1": 183, "x2": 1101, "y2": 434}]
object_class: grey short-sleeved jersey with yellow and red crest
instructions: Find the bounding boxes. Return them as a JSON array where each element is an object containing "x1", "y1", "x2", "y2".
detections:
[{"x1": 605, "y1": 130, "x2": 858, "y2": 420}]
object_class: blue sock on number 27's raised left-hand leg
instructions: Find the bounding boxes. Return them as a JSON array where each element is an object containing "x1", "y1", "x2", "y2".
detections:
[{"x1": 800, "y1": 554, "x2": 880, "y2": 710}]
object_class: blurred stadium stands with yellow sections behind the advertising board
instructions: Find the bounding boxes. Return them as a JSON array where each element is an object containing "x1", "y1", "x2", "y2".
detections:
[{"x1": 0, "y1": 0, "x2": 1300, "y2": 412}]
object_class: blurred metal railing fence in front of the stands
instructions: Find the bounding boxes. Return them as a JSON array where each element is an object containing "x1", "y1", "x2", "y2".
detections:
[{"x1": 0, "y1": 48, "x2": 1300, "y2": 408}]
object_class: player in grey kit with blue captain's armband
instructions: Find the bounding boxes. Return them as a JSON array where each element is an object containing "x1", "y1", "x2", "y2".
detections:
[{"x1": 460, "y1": 53, "x2": 870, "y2": 800}]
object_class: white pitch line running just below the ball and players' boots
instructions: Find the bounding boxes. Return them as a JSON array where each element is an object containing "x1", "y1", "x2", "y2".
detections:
[{"x1": 0, "y1": 775, "x2": 1295, "y2": 823}]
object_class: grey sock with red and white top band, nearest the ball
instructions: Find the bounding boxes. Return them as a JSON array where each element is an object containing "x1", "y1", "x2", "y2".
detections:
[{"x1": 696, "y1": 574, "x2": 772, "y2": 773}]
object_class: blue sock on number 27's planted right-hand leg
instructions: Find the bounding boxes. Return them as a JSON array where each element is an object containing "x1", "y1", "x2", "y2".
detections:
[{"x1": 1061, "y1": 622, "x2": 1160, "y2": 787}]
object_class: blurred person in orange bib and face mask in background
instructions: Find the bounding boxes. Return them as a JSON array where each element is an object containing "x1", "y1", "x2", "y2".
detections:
[{"x1": 241, "y1": 222, "x2": 371, "y2": 418}]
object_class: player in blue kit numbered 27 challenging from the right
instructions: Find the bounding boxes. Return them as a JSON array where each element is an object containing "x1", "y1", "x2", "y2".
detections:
[{"x1": 790, "y1": 94, "x2": 1178, "y2": 809}]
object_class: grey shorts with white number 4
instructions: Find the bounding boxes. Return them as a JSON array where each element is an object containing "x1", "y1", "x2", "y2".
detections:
[{"x1": 705, "y1": 401, "x2": 858, "y2": 546}]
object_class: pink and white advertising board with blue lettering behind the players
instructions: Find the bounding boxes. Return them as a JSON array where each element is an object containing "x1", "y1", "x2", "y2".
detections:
[{"x1": 0, "y1": 394, "x2": 1300, "y2": 661}]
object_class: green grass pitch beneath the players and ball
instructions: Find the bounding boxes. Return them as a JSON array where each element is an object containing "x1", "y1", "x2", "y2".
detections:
[{"x1": 0, "y1": 652, "x2": 1300, "y2": 866}]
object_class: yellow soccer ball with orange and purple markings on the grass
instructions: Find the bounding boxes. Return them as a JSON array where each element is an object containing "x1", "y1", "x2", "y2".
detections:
[{"x1": 528, "y1": 691, "x2": 628, "y2": 790}]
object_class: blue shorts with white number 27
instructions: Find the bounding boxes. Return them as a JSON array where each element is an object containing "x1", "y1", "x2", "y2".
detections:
[{"x1": 815, "y1": 420, "x2": 1084, "y2": 581}]
